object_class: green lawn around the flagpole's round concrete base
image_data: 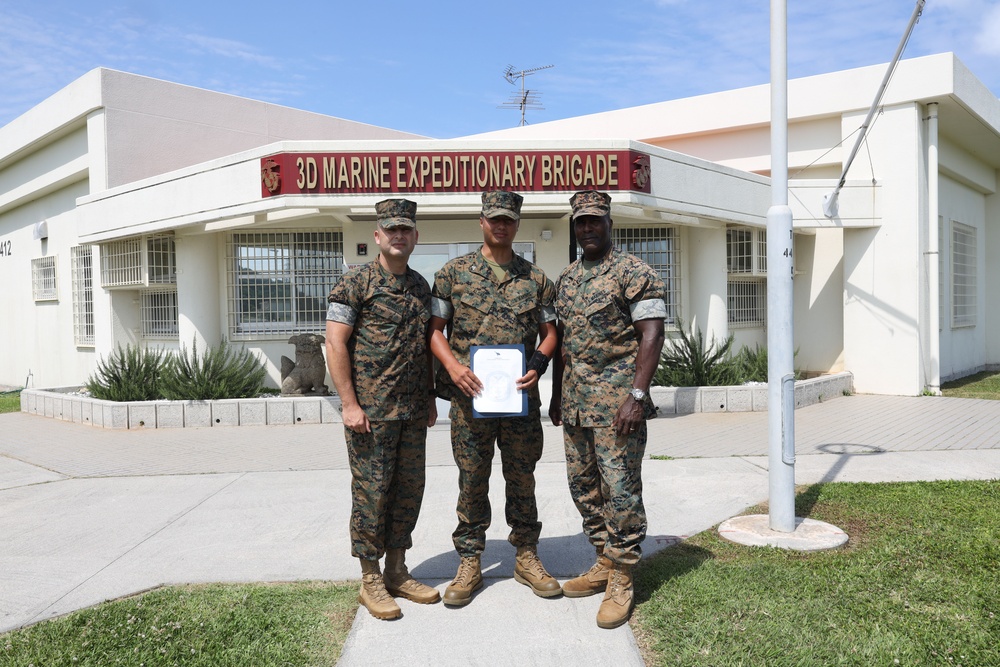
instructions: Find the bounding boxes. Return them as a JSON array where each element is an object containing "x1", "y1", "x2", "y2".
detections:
[{"x1": 632, "y1": 481, "x2": 1000, "y2": 666}]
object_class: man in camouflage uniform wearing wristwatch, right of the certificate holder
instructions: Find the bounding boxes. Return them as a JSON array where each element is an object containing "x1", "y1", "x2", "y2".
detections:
[{"x1": 549, "y1": 191, "x2": 666, "y2": 627}]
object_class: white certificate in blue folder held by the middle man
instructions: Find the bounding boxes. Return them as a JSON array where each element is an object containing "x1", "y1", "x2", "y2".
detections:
[{"x1": 470, "y1": 345, "x2": 528, "y2": 417}]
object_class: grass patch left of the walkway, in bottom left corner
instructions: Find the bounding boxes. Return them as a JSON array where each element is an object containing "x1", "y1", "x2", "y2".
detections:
[{"x1": 0, "y1": 582, "x2": 357, "y2": 667}]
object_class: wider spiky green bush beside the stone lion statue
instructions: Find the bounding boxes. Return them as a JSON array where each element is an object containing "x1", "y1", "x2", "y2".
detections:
[{"x1": 160, "y1": 341, "x2": 267, "y2": 401}]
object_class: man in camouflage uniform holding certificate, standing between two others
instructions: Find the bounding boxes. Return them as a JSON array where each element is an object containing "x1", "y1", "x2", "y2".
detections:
[{"x1": 431, "y1": 191, "x2": 560, "y2": 605}]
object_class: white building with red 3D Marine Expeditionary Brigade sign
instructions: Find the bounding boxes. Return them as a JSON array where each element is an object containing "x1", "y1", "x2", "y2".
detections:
[{"x1": 0, "y1": 54, "x2": 1000, "y2": 395}]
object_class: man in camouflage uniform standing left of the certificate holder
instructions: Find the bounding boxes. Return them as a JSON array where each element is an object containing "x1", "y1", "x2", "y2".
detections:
[{"x1": 327, "y1": 199, "x2": 440, "y2": 618}]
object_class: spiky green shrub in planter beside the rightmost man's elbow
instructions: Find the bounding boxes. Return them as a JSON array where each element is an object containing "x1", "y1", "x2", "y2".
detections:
[{"x1": 653, "y1": 322, "x2": 744, "y2": 387}]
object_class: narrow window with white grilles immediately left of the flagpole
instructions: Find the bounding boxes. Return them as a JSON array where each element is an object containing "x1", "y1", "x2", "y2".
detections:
[{"x1": 726, "y1": 225, "x2": 767, "y2": 328}]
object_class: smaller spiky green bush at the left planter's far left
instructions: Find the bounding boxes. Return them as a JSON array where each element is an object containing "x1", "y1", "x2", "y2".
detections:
[{"x1": 86, "y1": 345, "x2": 164, "y2": 401}]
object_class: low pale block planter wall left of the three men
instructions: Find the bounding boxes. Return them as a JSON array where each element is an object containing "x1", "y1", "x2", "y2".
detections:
[{"x1": 21, "y1": 387, "x2": 343, "y2": 429}]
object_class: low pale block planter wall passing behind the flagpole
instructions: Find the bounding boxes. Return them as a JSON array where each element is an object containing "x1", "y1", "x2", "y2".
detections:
[{"x1": 649, "y1": 372, "x2": 854, "y2": 415}]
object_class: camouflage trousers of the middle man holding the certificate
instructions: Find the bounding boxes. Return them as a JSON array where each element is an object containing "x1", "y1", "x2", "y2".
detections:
[{"x1": 448, "y1": 396, "x2": 543, "y2": 557}]
